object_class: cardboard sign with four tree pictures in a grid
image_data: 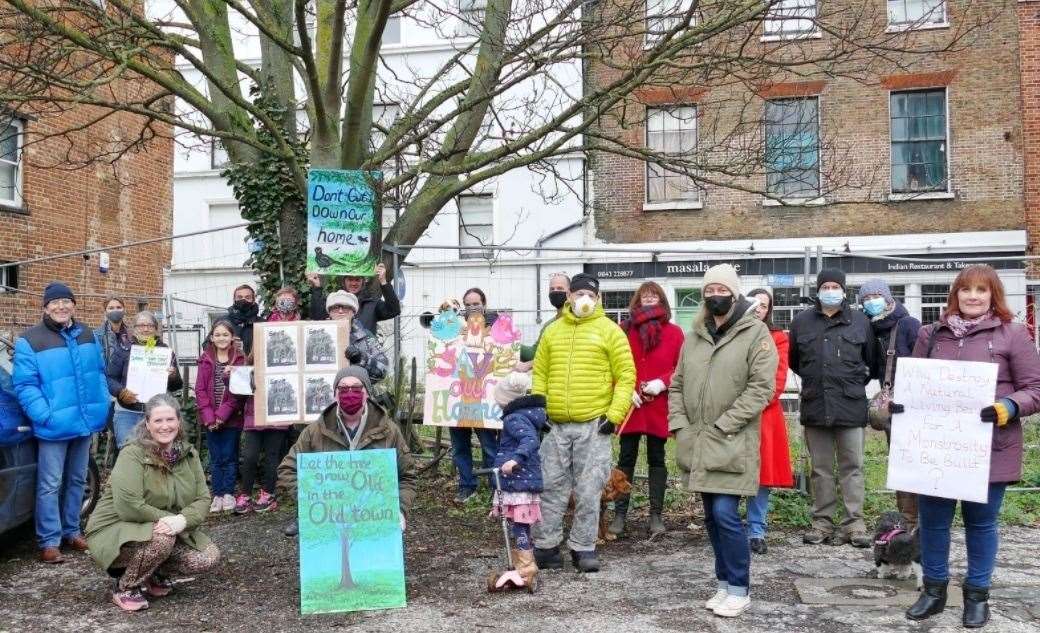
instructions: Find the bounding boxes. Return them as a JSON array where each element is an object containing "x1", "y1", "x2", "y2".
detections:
[{"x1": 253, "y1": 320, "x2": 350, "y2": 426}]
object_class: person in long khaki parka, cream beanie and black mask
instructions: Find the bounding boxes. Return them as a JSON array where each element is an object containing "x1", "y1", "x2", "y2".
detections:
[{"x1": 668, "y1": 264, "x2": 778, "y2": 617}]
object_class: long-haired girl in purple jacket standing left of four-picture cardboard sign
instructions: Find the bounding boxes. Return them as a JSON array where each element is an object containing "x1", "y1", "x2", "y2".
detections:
[{"x1": 196, "y1": 319, "x2": 245, "y2": 512}]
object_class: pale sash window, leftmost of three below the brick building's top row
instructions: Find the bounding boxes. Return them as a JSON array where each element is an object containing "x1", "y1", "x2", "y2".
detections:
[{"x1": 647, "y1": 106, "x2": 700, "y2": 203}]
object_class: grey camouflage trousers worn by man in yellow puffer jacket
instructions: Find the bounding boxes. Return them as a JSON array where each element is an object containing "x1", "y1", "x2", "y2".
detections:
[{"x1": 534, "y1": 421, "x2": 613, "y2": 552}]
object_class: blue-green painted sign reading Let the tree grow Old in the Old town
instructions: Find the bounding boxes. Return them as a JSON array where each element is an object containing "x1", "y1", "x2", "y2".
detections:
[{"x1": 296, "y1": 449, "x2": 405, "y2": 614}]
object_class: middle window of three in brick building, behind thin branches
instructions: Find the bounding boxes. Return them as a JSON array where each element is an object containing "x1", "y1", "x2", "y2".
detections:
[{"x1": 764, "y1": 97, "x2": 820, "y2": 199}]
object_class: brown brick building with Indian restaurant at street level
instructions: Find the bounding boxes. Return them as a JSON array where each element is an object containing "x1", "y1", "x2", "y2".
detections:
[{"x1": 586, "y1": 0, "x2": 1040, "y2": 323}]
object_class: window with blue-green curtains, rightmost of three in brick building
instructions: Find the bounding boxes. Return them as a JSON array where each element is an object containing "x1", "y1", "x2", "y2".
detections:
[{"x1": 890, "y1": 88, "x2": 947, "y2": 193}]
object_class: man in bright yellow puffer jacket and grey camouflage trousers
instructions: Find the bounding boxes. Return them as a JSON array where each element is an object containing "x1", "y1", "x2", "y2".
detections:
[{"x1": 531, "y1": 273, "x2": 635, "y2": 572}]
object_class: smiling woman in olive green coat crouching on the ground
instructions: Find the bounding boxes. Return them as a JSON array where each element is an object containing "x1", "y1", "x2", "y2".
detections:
[{"x1": 86, "y1": 393, "x2": 220, "y2": 611}]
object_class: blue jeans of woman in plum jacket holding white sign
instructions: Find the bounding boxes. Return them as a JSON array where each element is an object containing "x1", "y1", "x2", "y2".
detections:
[{"x1": 917, "y1": 483, "x2": 1008, "y2": 589}]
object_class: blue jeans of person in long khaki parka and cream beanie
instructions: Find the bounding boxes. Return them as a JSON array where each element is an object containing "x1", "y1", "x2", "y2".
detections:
[{"x1": 701, "y1": 493, "x2": 751, "y2": 596}]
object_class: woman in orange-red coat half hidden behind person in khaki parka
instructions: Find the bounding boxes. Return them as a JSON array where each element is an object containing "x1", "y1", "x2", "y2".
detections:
[{"x1": 748, "y1": 288, "x2": 795, "y2": 554}]
